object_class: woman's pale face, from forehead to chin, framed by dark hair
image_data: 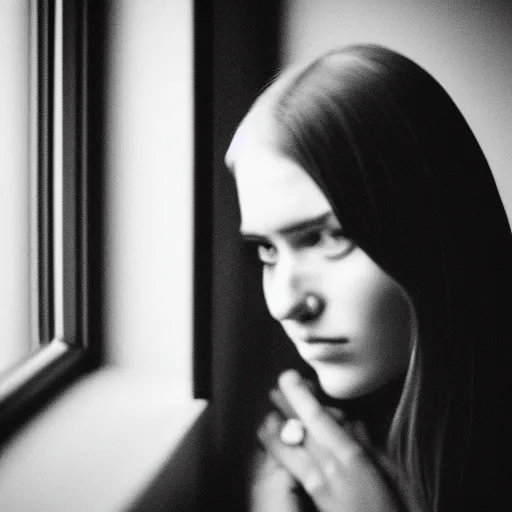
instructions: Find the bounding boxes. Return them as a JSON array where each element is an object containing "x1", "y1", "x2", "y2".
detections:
[{"x1": 234, "y1": 146, "x2": 414, "y2": 398}]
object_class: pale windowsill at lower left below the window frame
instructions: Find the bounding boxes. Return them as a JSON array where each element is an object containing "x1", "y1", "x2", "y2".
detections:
[{"x1": 0, "y1": 368, "x2": 207, "y2": 512}]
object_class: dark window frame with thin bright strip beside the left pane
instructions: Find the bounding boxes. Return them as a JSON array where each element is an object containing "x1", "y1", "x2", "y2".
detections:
[{"x1": 0, "y1": 0, "x2": 93, "y2": 439}]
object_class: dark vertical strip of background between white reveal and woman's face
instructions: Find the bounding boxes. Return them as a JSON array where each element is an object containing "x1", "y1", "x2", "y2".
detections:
[{"x1": 207, "y1": 0, "x2": 316, "y2": 511}]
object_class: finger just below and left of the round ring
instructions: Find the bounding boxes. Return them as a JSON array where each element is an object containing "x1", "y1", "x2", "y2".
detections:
[{"x1": 258, "y1": 411, "x2": 325, "y2": 495}]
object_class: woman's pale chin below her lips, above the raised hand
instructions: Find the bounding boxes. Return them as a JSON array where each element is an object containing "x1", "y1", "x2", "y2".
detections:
[{"x1": 314, "y1": 364, "x2": 385, "y2": 400}]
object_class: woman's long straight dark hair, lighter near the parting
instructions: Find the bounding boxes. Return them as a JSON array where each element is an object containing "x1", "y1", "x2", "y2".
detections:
[{"x1": 228, "y1": 45, "x2": 512, "y2": 511}]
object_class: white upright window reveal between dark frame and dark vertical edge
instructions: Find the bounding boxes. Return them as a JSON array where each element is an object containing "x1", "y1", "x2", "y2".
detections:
[{"x1": 105, "y1": 0, "x2": 193, "y2": 389}]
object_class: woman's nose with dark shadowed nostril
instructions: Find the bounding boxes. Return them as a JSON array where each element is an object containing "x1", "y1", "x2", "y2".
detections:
[{"x1": 263, "y1": 254, "x2": 325, "y2": 323}]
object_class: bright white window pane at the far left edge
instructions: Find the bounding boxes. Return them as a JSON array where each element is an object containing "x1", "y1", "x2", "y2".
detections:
[{"x1": 0, "y1": 0, "x2": 30, "y2": 372}]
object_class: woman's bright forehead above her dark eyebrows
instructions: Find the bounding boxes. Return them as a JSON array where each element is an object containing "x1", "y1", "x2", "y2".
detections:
[{"x1": 234, "y1": 145, "x2": 331, "y2": 234}]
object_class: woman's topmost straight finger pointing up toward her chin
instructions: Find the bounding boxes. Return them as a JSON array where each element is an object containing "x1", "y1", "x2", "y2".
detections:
[{"x1": 279, "y1": 370, "x2": 367, "y2": 465}]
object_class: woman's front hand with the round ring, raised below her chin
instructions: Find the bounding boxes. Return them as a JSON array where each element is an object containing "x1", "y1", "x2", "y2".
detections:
[{"x1": 258, "y1": 371, "x2": 399, "y2": 512}]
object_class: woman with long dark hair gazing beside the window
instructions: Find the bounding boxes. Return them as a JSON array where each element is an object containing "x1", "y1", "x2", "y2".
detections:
[{"x1": 226, "y1": 45, "x2": 512, "y2": 511}]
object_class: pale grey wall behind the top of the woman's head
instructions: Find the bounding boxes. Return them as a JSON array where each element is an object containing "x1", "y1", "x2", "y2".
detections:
[{"x1": 283, "y1": 0, "x2": 512, "y2": 219}]
